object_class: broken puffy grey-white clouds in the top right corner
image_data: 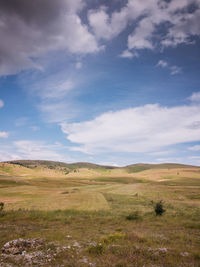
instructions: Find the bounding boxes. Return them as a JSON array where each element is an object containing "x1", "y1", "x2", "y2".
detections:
[{"x1": 88, "y1": 0, "x2": 200, "y2": 55}]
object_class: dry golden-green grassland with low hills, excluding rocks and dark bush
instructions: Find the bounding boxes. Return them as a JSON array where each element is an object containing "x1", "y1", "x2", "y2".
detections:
[{"x1": 0, "y1": 161, "x2": 200, "y2": 267}]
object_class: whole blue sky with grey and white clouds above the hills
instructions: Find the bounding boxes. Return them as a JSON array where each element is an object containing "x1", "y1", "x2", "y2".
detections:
[{"x1": 0, "y1": 0, "x2": 200, "y2": 166}]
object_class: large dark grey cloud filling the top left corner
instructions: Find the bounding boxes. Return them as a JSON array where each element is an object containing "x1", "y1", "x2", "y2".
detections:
[{"x1": 0, "y1": 0, "x2": 99, "y2": 75}]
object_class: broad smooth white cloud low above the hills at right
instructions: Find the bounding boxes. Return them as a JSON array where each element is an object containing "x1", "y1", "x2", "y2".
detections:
[{"x1": 61, "y1": 100, "x2": 200, "y2": 153}]
